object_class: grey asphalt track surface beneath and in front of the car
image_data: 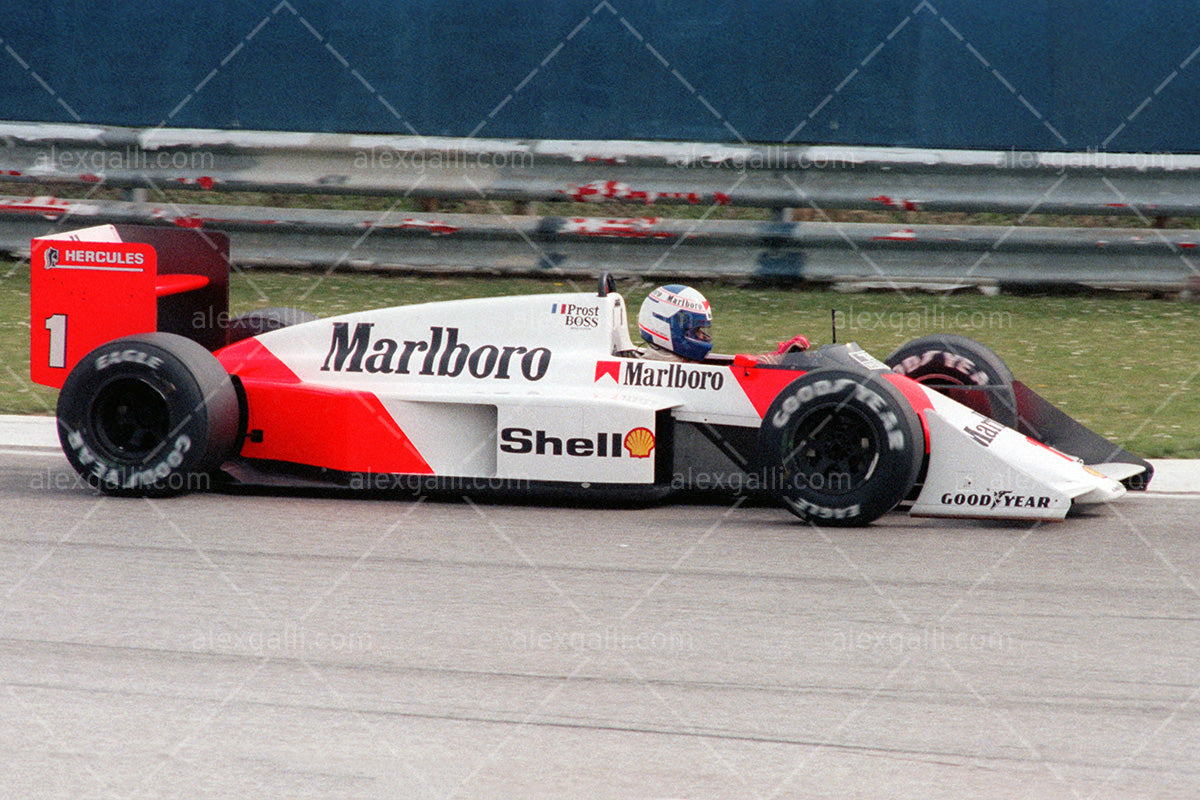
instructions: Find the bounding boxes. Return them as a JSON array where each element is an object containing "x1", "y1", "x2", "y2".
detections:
[{"x1": 0, "y1": 422, "x2": 1200, "y2": 799}]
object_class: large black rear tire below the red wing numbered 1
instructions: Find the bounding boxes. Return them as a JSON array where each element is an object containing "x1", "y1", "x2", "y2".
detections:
[{"x1": 58, "y1": 332, "x2": 239, "y2": 497}]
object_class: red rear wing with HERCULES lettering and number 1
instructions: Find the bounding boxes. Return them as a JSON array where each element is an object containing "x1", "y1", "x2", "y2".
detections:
[{"x1": 29, "y1": 224, "x2": 229, "y2": 389}]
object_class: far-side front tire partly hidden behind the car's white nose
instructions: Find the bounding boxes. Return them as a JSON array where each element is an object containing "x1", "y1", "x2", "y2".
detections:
[{"x1": 883, "y1": 333, "x2": 1019, "y2": 428}]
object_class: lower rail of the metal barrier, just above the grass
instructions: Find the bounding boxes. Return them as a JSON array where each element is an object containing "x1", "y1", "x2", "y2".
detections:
[{"x1": 0, "y1": 198, "x2": 1200, "y2": 291}]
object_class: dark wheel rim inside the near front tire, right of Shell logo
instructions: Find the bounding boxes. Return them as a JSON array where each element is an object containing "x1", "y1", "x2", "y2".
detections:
[{"x1": 784, "y1": 405, "x2": 880, "y2": 494}]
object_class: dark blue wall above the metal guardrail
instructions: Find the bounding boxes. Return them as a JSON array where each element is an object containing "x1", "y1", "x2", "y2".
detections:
[{"x1": 0, "y1": 0, "x2": 1200, "y2": 152}]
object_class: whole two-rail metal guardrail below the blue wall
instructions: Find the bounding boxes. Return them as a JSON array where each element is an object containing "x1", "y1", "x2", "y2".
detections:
[{"x1": 0, "y1": 122, "x2": 1200, "y2": 290}]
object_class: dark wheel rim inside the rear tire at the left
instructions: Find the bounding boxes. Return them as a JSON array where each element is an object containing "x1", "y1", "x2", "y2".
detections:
[{"x1": 91, "y1": 378, "x2": 170, "y2": 464}]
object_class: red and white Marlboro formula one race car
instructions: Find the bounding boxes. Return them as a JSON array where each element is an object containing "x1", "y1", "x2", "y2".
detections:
[{"x1": 31, "y1": 225, "x2": 1151, "y2": 525}]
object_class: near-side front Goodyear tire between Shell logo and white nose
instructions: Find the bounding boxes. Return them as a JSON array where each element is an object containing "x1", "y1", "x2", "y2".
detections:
[{"x1": 758, "y1": 367, "x2": 925, "y2": 527}]
